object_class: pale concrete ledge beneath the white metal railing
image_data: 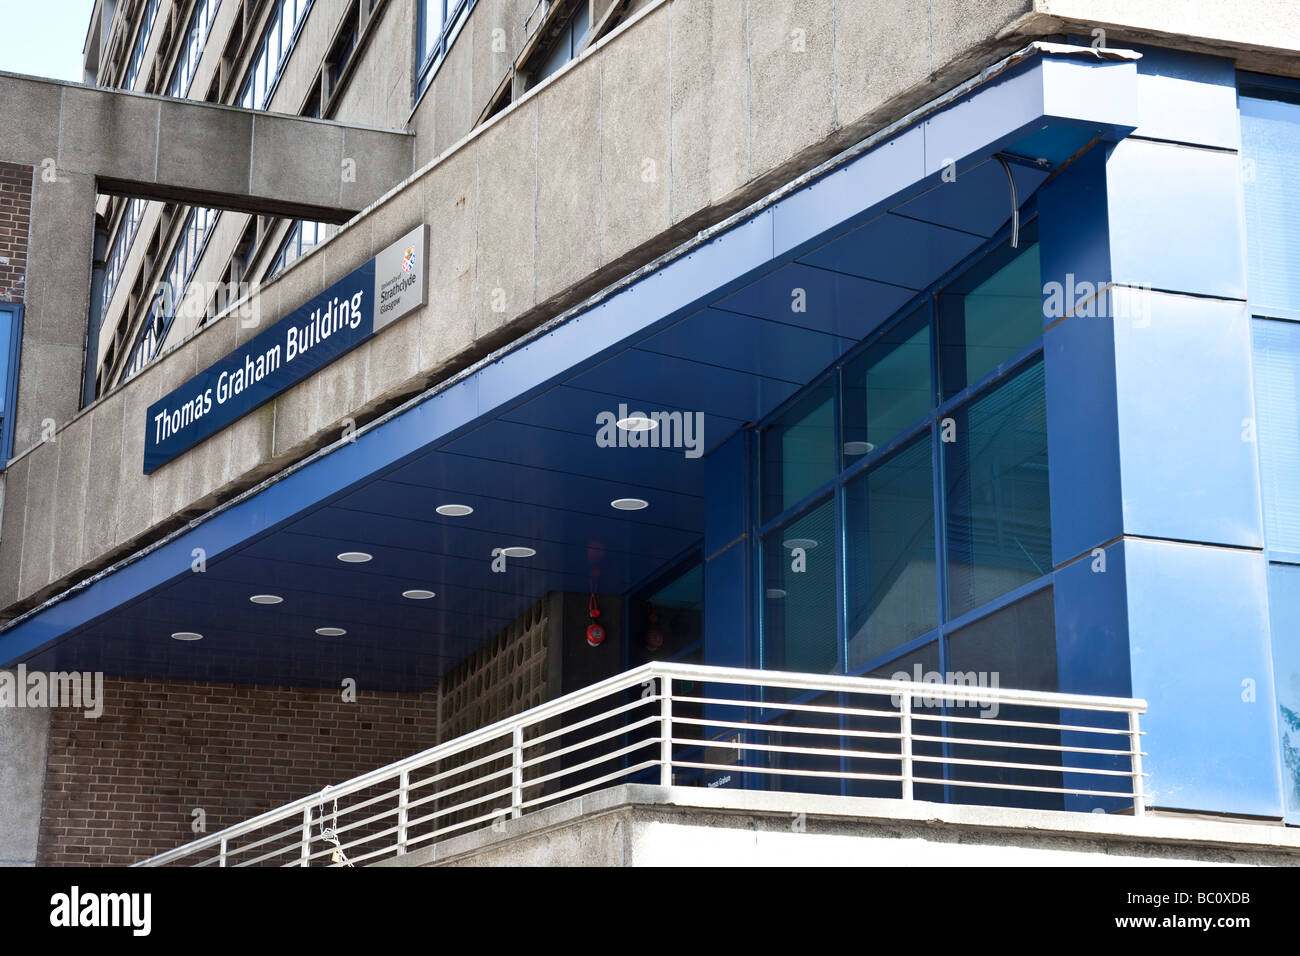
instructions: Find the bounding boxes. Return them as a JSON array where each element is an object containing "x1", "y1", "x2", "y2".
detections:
[{"x1": 374, "y1": 784, "x2": 1300, "y2": 866}]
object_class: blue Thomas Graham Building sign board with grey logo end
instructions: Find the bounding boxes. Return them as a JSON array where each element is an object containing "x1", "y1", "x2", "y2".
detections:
[{"x1": 144, "y1": 225, "x2": 428, "y2": 475}]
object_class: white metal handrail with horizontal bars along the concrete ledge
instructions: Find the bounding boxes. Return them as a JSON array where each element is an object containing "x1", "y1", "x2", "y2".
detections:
[{"x1": 137, "y1": 662, "x2": 1147, "y2": 866}]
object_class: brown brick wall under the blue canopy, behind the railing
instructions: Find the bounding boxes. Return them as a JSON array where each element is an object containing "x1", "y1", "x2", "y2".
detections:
[{"x1": 36, "y1": 678, "x2": 438, "y2": 865}]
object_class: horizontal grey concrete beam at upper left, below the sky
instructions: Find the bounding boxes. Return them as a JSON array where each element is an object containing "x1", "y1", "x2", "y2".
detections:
[{"x1": 0, "y1": 73, "x2": 415, "y2": 222}]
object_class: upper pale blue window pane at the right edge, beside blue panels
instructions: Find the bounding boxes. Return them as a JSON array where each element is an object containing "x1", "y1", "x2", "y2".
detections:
[{"x1": 1242, "y1": 90, "x2": 1300, "y2": 316}]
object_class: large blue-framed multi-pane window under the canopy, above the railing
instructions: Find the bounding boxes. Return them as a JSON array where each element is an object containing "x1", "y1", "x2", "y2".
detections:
[{"x1": 755, "y1": 224, "x2": 1045, "y2": 680}]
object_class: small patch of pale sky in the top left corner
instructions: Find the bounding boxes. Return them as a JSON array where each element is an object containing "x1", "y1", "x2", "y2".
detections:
[{"x1": 0, "y1": 0, "x2": 95, "y2": 83}]
